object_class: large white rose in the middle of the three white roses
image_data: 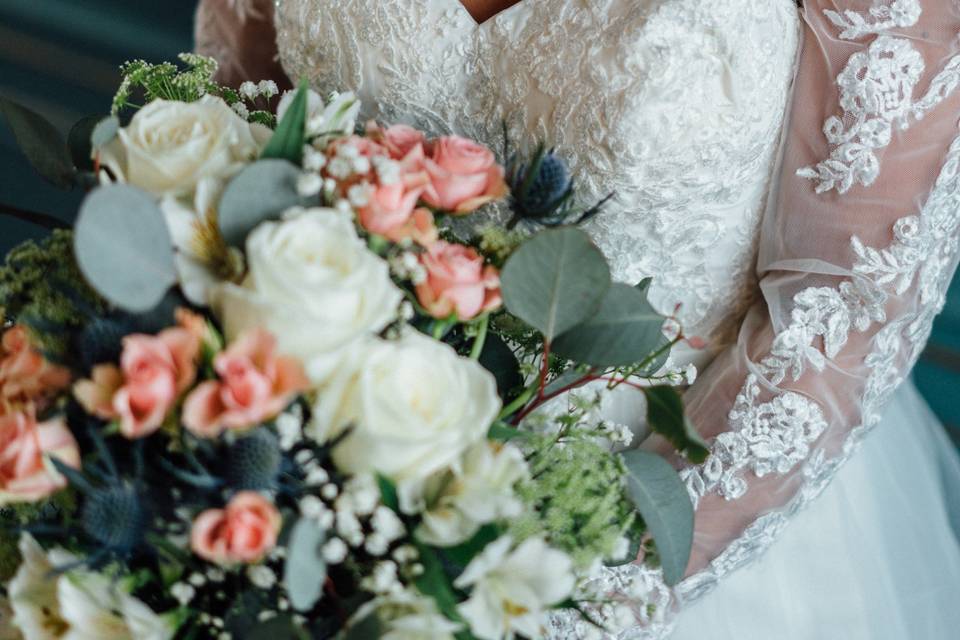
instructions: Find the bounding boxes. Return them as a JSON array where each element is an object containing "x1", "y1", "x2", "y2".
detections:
[{"x1": 211, "y1": 209, "x2": 403, "y2": 384}]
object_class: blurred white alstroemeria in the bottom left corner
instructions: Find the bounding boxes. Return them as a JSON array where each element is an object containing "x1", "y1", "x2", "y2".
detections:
[{"x1": 8, "y1": 534, "x2": 176, "y2": 640}]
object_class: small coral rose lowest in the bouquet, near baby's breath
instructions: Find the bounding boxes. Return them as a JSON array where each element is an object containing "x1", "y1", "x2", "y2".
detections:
[{"x1": 190, "y1": 491, "x2": 282, "y2": 565}]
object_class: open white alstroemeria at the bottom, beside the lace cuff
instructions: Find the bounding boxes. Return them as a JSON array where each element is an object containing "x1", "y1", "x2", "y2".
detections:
[{"x1": 454, "y1": 536, "x2": 575, "y2": 640}]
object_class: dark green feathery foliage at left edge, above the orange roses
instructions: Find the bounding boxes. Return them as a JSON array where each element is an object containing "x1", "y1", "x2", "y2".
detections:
[{"x1": 0, "y1": 230, "x2": 105, "y2": 355}]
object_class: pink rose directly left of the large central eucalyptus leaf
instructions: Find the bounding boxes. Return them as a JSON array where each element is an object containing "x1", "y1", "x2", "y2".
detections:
[{"x1": 417, "y1": 240, "x2": 502, "y2": 321}]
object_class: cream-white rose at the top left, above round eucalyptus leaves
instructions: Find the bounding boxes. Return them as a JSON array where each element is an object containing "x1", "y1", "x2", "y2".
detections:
[{"x1": 100, "y1": 96, "x2": 271, "y2": 196}]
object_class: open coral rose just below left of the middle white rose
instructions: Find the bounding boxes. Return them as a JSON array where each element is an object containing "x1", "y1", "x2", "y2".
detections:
[{"x1": 183, "y1": 329, "x2": 309, "y2": 438}]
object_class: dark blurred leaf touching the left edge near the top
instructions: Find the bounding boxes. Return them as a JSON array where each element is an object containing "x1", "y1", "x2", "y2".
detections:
[{"x1": 0, "y1": 98, "x2": 76, "y2": 189}]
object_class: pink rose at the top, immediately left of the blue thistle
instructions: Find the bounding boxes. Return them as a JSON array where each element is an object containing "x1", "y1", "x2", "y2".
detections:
[{"x1": 423, "y1": 136, "x2": 507, "y2": 214}]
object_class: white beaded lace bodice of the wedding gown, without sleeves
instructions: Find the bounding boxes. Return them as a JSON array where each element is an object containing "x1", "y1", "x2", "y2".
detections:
[{"x1": 276, "y1": 0, "x2": 799, "y2": 364}]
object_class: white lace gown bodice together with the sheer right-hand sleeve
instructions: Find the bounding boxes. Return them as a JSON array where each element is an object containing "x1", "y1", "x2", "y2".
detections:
[{"x1": 195, "y1": 0, "x2": 960, "y2": 640}]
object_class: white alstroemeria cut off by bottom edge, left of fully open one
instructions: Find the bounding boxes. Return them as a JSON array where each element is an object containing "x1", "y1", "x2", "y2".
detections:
[{"x1": 351, "y1": 591, "x2": 462, "y2": 640}]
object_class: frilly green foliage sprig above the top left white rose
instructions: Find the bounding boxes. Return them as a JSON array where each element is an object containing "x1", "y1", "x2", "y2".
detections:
[{"x1": 111, "y1": 53, "x2": 276, "y2": 128}]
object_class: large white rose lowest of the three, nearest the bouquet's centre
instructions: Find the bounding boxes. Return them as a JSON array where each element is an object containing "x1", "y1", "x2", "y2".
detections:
[{"x1": 307, "y1": 331, "x2": 500, "y2": 490}]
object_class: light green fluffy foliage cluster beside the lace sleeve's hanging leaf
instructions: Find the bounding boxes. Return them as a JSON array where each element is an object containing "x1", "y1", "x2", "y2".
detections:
[{"x1": 510, "y1": 432, "x2": 639, "y2": 569}]
